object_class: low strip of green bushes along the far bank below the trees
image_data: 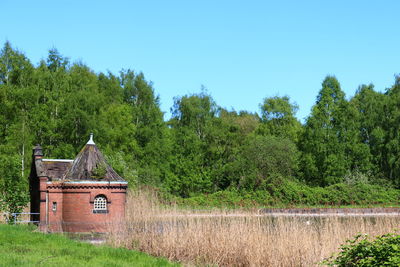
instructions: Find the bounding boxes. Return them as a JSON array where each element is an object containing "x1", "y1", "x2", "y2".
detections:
[{"x1": 175, "y1": 182, "x2": 400, "y2": 207}]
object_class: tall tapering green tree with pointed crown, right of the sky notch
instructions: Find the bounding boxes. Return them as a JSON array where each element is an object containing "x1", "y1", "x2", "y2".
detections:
[{"x1": 301, "y1": 76, "x2": 349, "y2": 185}]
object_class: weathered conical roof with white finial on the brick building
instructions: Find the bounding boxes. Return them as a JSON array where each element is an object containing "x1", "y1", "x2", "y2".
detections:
[{"x1": 64, "y1": 134, "x2": 124, "y2": 181}]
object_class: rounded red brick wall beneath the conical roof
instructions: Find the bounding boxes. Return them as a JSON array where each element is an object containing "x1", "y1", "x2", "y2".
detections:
[{"x1": 41, "y1": 182, "x2": 127, "y2": 232}]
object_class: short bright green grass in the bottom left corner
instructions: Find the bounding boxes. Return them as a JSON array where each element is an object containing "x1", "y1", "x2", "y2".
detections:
[{"x1": 0, "y1": 225, "x2": 179, "y2": 267}]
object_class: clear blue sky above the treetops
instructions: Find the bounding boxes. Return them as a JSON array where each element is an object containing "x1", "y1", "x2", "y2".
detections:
[{"x1": 0, "y1": 0, "x2": 400, "y2": 122}]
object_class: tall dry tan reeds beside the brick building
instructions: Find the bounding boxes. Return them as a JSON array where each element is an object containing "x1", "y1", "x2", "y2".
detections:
[{"x1": 109, "y1": 192, "x2": 400, "y2": 266}]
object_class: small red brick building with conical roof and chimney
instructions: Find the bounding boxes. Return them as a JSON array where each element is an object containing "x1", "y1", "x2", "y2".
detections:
[{"x1": 30, "y1": 135, "x2": 128, "y2": 232}]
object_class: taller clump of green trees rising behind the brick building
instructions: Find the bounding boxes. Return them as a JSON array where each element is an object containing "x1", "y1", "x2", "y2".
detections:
[{"x1": 0, "y1": 42, "x2": 170, "y2": 199}]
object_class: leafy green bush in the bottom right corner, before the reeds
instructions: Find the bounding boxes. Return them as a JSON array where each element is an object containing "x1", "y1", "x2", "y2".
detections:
[{"x1": 321, "y1": 234, "x2": 400, "y2": 267}]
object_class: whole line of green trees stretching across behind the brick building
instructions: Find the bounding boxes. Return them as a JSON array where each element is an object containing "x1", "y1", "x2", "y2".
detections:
[{"x1": 0, "y1": 42, "x2": 400, "y2": 210}]
